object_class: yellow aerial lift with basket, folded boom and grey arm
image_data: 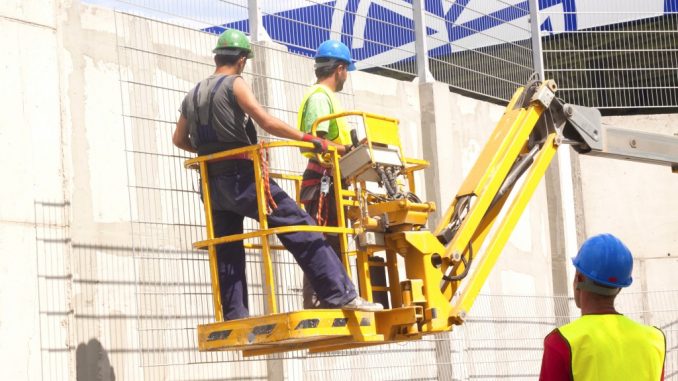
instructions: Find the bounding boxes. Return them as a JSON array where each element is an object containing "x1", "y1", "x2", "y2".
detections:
[{"x1": 186, "y1": 80, "x2": 678, "y2": 356}]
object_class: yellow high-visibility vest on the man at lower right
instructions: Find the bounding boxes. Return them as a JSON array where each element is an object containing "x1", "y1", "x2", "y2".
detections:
[{"x1": 558, "y1": 314, "x2": 666, "y2": 381}]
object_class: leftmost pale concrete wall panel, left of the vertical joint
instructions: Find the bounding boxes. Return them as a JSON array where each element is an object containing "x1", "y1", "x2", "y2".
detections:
[{"x1": 0, "y1": 0, "x2": 61, "y2": 380}]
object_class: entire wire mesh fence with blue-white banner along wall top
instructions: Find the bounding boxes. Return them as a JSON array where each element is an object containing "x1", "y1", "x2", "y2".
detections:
[{"x1": 90, "y1": 0, "x2": 678, "y2": 113}]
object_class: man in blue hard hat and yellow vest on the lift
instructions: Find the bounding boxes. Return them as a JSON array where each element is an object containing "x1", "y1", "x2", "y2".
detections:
[{"x1": 297, "y1": 40, "x2": 362, "y2": 308}]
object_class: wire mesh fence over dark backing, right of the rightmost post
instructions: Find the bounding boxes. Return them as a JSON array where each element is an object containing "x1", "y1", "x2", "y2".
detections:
[{"x1": 541, "y1": 4, "x2": 678, "y2": 113}]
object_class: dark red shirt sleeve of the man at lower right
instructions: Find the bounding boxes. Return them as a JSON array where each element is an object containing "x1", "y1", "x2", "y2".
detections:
[{"x1": 539, "y1": 329, "x2": 572, "y2": 381}]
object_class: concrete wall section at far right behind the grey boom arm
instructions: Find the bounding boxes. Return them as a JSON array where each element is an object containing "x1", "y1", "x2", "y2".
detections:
[{"x1": 580, "y1": 114, "x2": 678, "y2": 308}]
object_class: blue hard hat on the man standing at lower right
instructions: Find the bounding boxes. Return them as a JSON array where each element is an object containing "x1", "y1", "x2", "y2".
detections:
[{"x1": 572, "y1": 234, "x2": 633, "y2": 287}]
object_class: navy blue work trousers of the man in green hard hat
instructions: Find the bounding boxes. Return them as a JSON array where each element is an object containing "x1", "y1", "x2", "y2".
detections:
[{"x1": 209, "y1": 160, "x2": 357, "y2": 320}]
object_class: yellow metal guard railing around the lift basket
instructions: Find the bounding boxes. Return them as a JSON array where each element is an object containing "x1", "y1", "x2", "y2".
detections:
[{"x1": 185, "y1": 111, "x2": 428, "y2": 322}]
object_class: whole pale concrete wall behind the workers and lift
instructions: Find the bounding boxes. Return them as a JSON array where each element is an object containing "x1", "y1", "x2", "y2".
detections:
[{"x1": 0, "y1": 0, "x2": 678, "y2": 380}]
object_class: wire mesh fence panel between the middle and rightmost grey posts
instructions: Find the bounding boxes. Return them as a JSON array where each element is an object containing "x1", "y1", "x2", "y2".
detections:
[{"x1": 426, "y1": 1, "x2": 534, "y2": 101}]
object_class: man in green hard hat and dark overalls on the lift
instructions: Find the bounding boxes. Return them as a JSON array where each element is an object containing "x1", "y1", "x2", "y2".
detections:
[{"x1": 172, "y1": 29, "x2": 381, "y2": 320}]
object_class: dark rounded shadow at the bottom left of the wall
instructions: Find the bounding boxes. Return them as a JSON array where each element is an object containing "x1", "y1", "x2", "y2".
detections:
[{"x1": 75, "y1": 339, "x2": 115, "y2": 381}]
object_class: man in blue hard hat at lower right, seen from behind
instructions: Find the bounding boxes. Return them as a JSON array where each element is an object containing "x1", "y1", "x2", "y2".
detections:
[{"x1": 540, "y1": 234, "x2": 666, "y2": 381}]
